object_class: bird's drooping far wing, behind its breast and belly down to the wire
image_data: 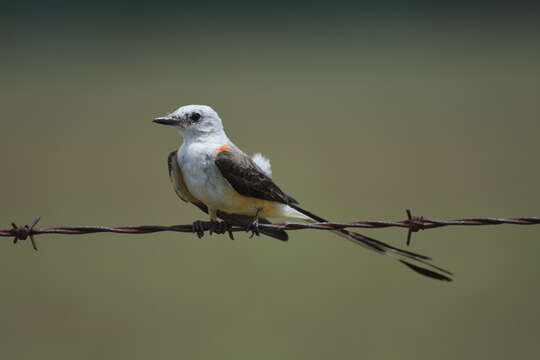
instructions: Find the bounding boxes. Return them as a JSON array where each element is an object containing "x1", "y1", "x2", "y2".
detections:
[{"x1": 167, "y1": 151, "x2": 289, "y2": 241}]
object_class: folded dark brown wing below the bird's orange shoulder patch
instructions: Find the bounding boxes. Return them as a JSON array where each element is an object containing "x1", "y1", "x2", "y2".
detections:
[{"x1": 215, "y1": 150, "x2": 298, "y2": 204}]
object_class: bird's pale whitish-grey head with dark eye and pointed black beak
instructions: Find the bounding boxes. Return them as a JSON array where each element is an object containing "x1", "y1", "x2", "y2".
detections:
[{"x1": 154, "y1": 105, "x2": 223, "y2": 139}]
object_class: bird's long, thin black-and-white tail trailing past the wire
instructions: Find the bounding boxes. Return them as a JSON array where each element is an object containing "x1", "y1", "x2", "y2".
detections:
[{"x1": 289, "y1": 204, "x2": 452, "y2": 281}]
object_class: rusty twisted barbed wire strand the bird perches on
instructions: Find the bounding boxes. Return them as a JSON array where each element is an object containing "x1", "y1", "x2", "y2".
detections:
[{"x1": 0, "y1": 210, "x2": 540, "y2": 250}]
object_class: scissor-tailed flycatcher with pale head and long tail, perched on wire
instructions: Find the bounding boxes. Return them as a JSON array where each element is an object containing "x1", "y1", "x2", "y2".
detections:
[{"x1": 153, "y1": 105, "x2": 453, "y2": 281}]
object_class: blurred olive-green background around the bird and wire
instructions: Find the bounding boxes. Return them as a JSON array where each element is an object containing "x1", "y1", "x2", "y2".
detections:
[{"x1": 0, "y1": 1, "x2": 540, "y2": 359}]
